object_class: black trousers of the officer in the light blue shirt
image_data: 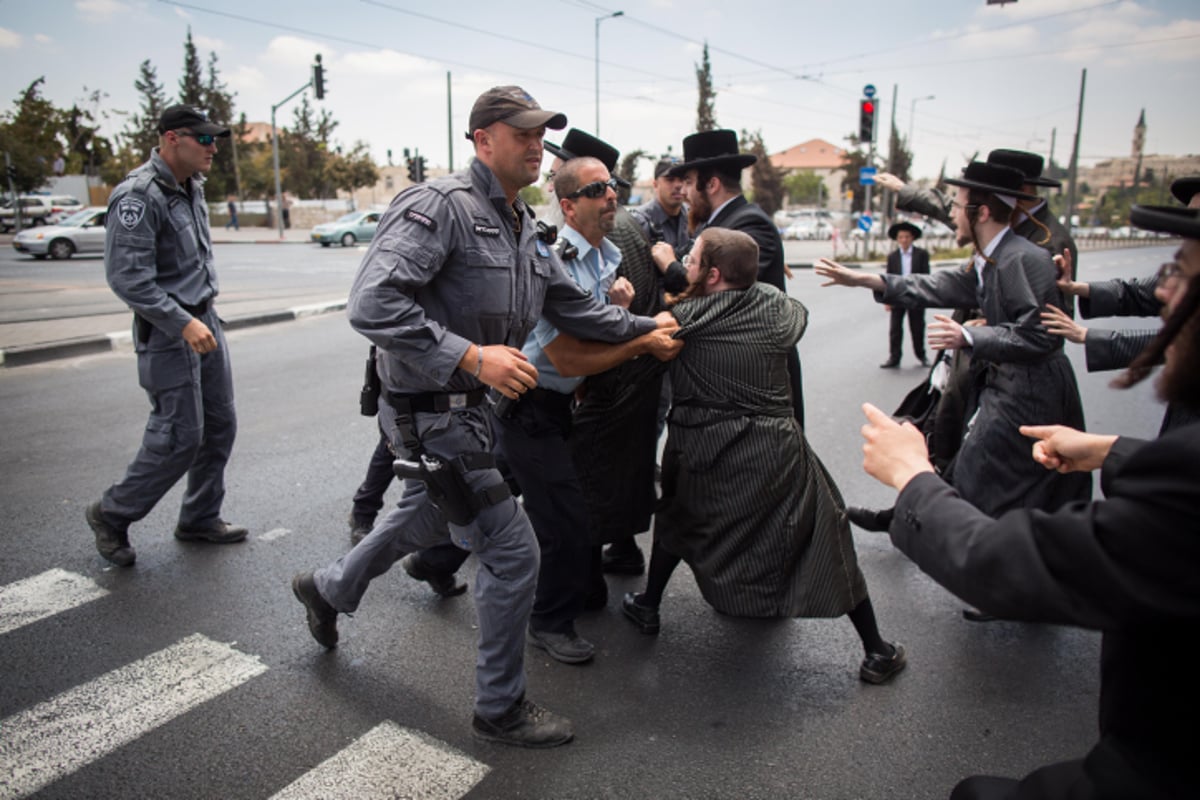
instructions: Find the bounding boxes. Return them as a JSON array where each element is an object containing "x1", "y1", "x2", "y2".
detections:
[{"x1": 496, "y1": 389, "x2": 592, "y2": 633}]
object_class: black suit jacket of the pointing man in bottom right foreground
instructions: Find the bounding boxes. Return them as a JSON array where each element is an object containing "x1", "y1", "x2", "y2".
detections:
[{"x1": 889, "y1": 425, "x2": 1200, "y2": 799}]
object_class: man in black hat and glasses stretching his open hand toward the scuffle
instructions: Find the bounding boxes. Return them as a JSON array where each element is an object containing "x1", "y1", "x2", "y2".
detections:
[{"x1": 814, "y1": 162, "x2": 1092, "y2": 515}]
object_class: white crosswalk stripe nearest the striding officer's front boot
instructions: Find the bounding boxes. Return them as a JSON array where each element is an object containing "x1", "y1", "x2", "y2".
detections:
[{"x1": 271, "y1": 722, "x2": 491, "y2": 800}]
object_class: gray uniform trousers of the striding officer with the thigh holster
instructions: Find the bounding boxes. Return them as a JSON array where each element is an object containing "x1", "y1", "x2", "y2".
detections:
[{"x1": 314, "y1": 398, "x2": 539, "y2": 718}]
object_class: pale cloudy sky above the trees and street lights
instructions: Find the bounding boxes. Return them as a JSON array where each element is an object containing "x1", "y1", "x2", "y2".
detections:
[{"x1": 0, "y1": 0, "x2": 1200, "y2": 183}]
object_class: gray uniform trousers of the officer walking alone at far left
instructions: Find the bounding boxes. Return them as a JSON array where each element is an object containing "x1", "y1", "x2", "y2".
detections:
[{"x1": 100, "y1": 303, "x2": 238, "y2": 530}]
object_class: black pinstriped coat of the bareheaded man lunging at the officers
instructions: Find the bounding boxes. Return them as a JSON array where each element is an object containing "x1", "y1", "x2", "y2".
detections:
[{"x1": 654, "y1": 283, "x2": 866, "y2": 616}]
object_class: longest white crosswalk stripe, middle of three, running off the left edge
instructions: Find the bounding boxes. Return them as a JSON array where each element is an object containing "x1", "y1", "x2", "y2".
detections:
[{"x1": 0, "y1": 633, "x2": 266, "y2": 800}]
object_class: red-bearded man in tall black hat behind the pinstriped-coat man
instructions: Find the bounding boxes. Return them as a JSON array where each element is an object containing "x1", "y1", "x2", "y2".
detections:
[{"x1": 654, "y1": 130, "x2": 804, "y2": 428}]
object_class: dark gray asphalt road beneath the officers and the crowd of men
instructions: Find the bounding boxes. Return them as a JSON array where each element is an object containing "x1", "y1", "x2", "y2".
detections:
[{"x1": 0, "y1": 247, "x2": 1170, "y2": 799}]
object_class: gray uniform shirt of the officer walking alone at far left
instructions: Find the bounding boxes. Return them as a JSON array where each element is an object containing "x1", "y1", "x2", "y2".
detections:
[{"x1": 104, "y1": 148, "x2": 217, "y2": 336}]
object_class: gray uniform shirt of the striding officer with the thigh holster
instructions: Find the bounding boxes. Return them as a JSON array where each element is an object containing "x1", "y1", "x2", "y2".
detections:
[{"x1": 347, "y1": 160, "x2": 655, "y2": 395}]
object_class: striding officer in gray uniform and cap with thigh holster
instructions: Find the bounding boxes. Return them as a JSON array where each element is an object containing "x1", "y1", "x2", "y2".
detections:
[{"x1": 292, "y1": 86, "x2": 656, "y2": 747}]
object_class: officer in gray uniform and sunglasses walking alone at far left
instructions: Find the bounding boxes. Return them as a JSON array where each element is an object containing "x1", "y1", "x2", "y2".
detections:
[{"x1": 85, "y1": 106, "x2": 246, "y2": 566}]
